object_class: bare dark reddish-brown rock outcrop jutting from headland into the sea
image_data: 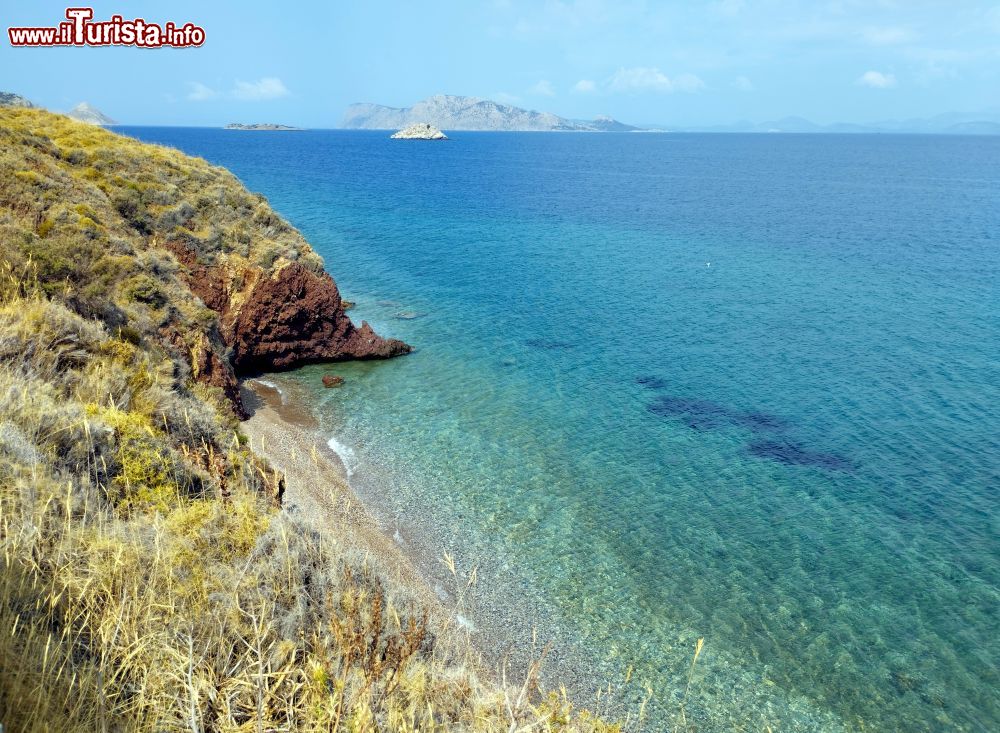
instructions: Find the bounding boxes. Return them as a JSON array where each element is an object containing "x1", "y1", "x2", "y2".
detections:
[{"x1": 167, "y1": 243, "x2": 411, "y2": 416}]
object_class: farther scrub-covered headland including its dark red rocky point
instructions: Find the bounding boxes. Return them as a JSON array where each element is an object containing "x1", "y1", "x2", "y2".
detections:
[{"x1": 0, "y1": 107, "x2": 410, "y2": 417}]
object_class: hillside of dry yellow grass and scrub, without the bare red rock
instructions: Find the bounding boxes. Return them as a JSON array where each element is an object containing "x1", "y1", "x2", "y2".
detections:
[{"x1": 0, "y1": 108, "x2": 614, "y2": 731}]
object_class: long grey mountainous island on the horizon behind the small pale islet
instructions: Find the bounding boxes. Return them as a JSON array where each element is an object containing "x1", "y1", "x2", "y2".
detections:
[{"x1": 341, "y1": 94, "x2": 639, "y2": 132}]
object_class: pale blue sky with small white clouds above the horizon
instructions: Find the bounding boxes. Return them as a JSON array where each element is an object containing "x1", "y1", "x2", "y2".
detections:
[{"x1": 0, "y1": 0, "x2": 1000, "y2": 127}]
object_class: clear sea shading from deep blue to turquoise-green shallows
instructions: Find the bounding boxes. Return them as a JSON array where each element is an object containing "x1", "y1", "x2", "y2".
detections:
[{"x1": 126, "y1": 128, "x2": 1000, "y2": 731}]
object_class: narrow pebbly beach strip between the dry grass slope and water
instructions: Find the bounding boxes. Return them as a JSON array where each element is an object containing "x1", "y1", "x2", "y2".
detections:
[{"x1": 242, "y1": 379, "x2": 621, "y2": 712}]
